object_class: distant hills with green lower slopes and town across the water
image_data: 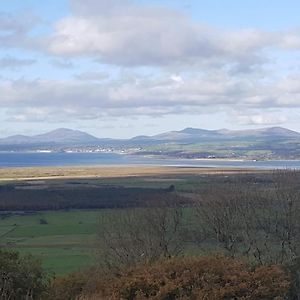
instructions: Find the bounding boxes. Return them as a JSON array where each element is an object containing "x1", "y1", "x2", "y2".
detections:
[{"x1": 0, "y1": 127, "x2": 300, "y2": 160}]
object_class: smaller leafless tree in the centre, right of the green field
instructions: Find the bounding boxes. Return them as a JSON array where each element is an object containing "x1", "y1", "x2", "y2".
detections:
[{"x1": 99, "y1": 201, "x2": 183, "y2": 268}]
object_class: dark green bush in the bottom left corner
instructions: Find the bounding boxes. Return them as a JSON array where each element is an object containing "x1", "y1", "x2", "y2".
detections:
[{"x1": 0, "y1": 250, "x2": 49, "y2": 300}]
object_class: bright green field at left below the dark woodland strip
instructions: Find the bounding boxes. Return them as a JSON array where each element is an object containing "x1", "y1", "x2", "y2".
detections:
[{"x1": 0, "y1": 210, "x2": 104, "y2": 274}]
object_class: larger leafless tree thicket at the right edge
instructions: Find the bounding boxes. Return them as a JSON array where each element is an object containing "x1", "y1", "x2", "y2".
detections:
[{"x1": 196, "y1": 170, "x2": 300, "y2": 264}]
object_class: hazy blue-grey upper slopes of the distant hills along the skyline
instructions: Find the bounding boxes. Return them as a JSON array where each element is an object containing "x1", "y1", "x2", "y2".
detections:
[{"x1": 0, "y1": 127, "x2": 300, "y2": 146}]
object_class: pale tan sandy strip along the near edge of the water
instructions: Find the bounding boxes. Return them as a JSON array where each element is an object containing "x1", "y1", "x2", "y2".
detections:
[{"x1": 0, "y1": 165, "x2": 268, "y2": 181}]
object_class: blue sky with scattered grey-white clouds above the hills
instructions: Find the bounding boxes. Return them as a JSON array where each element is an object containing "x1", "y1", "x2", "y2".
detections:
[{"x1": 0, "y1": 0, "x2": 300, "y2": 138}]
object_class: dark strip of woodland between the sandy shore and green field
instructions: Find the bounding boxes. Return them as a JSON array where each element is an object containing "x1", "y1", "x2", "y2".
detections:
[{"x1": 0, "y1": 183, "x2": 178, "y2": 212}]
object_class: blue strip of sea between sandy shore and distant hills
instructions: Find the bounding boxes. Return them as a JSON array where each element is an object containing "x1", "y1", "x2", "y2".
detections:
[{"x1": 0, "y1": 152, "x2": 300, "y2": 169}]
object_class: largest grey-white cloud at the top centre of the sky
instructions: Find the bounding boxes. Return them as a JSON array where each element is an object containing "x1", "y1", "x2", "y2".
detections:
[{"x1": 50, "y1": 1, "x2": 243, "y2": 66}]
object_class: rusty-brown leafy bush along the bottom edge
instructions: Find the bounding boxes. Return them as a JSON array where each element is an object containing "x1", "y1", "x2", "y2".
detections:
[{"x1": 80, "y1": 257, "x2": 289, "y2": 300}]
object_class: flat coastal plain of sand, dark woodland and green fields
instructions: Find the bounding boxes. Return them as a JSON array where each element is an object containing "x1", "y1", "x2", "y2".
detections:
[{"x1": 0, "y1": 166, "x2": 269, "y2": 274}]
